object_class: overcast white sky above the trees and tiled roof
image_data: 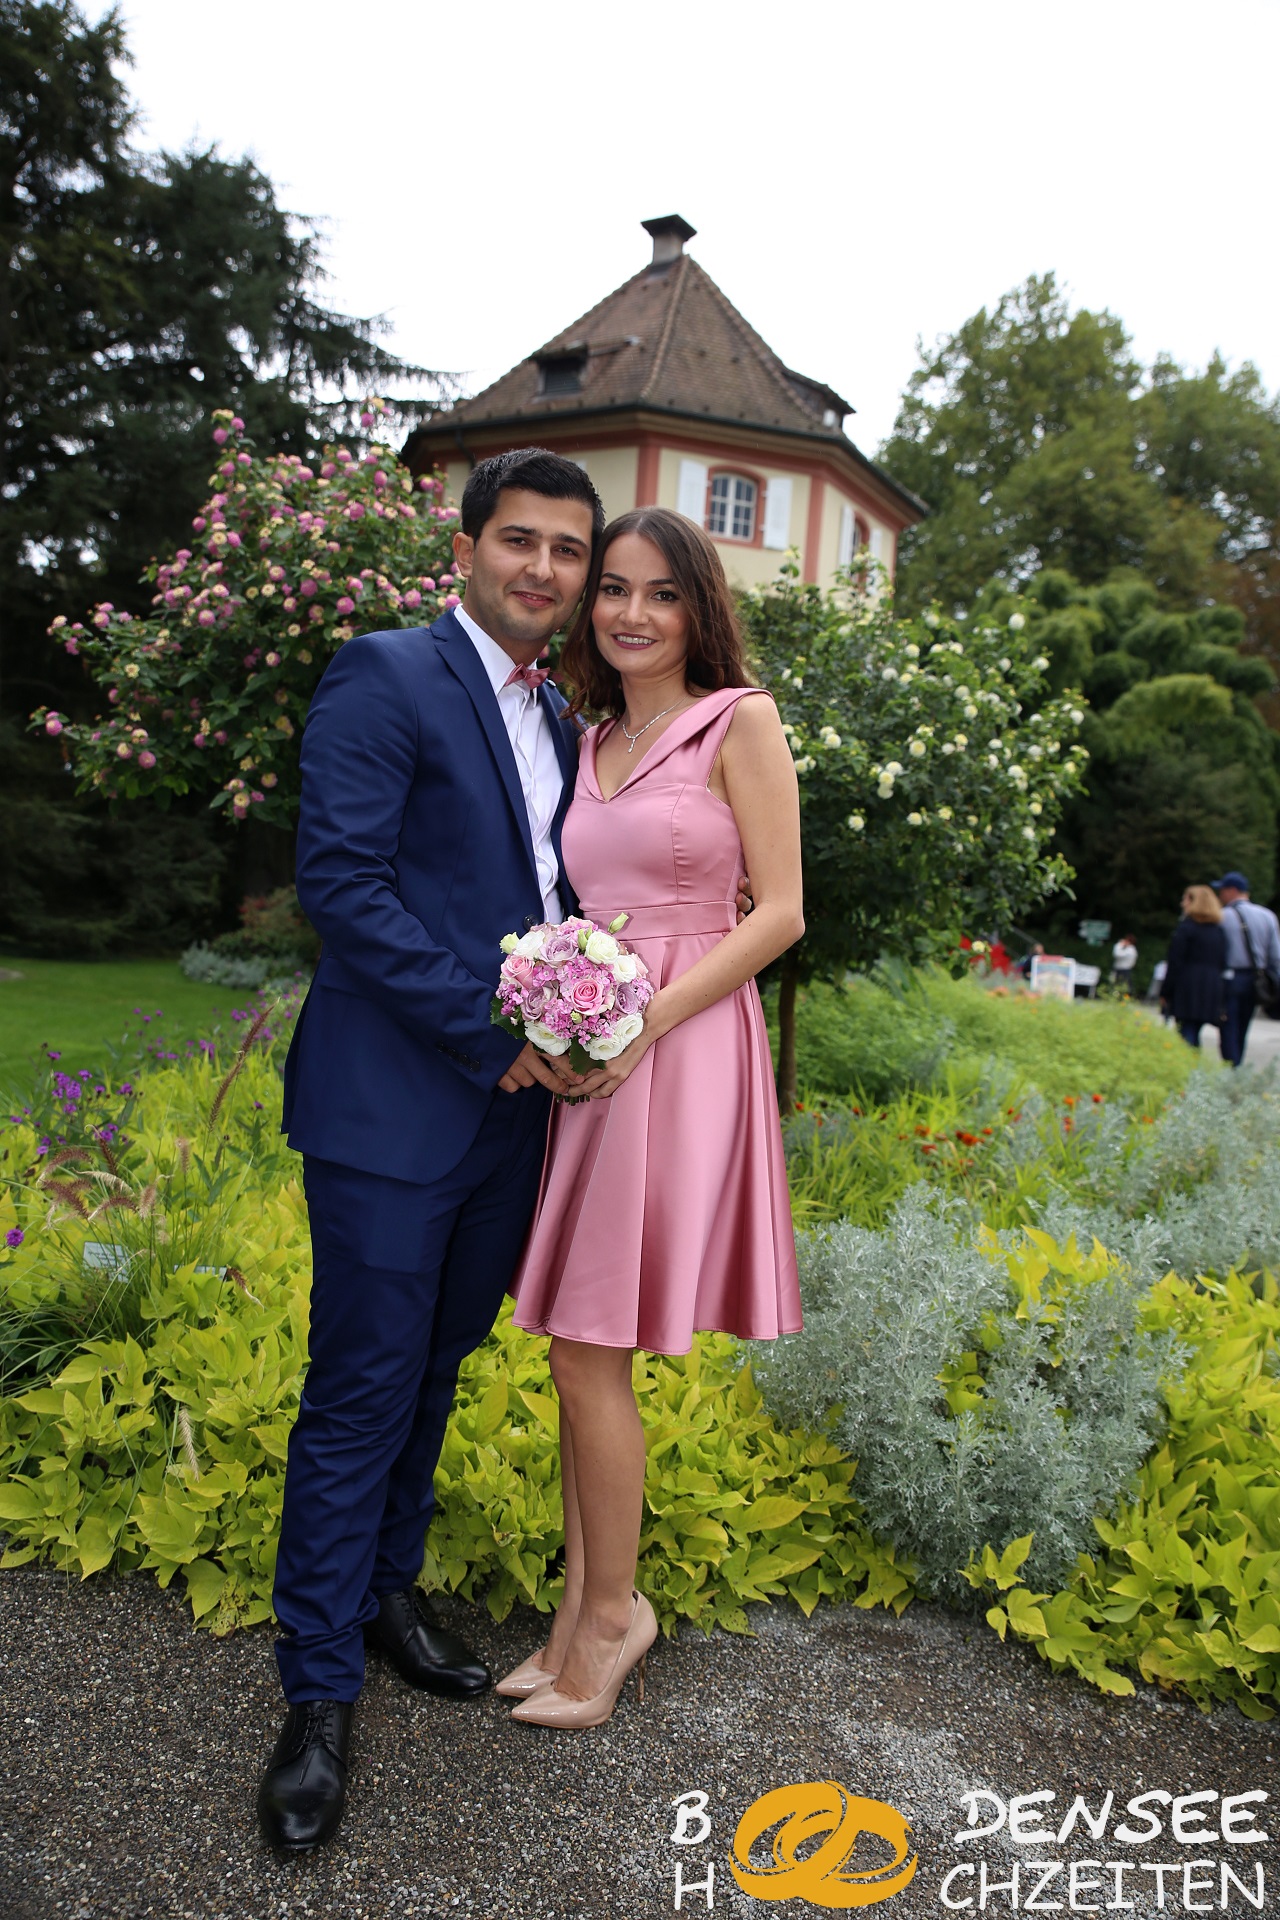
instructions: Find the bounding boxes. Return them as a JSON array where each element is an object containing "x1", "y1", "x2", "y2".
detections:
[{"x1": 119, "y1": 0, "x2": 1280, "y2": 451}]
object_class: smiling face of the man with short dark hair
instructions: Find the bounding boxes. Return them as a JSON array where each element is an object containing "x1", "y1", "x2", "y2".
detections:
[{"x1": 453, "y1": 488, "x2": 593, "y2": 662}]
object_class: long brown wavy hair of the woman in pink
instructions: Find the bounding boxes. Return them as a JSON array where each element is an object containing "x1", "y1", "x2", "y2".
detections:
[{"x1": 560, "y1": 507, "x2": 754, "y2": 718}]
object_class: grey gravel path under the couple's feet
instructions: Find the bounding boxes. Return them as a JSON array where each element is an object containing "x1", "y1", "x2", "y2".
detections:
[{"x1": 0, "y1": 1569, "x2": 1280, "y2": 1920}]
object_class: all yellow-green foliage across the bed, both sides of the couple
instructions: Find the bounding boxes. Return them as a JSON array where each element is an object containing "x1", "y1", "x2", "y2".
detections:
[{"x1": 0, "y1": 1013, "x2": 1280, "y2": 1715}]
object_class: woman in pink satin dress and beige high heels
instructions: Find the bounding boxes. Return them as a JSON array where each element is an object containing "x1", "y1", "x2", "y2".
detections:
[{"x1": 499, "y1": 507, "x2": 804, "y2": 1726}]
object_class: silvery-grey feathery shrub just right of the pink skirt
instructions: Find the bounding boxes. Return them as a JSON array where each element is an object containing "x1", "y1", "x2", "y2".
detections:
[{"x1": 752, "y1": 1183, "x2": 1174, "y2": 1601}]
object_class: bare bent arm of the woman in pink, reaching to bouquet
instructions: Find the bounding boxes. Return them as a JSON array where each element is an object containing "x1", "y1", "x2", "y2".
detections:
[{"x1": 578, "y1": 699, "x2": 804, "y2": 1100}]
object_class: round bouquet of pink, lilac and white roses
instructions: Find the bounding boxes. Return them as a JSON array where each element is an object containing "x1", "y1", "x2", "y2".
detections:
[{"x1": 491, "y1": 914, "x2": 654, "y2": 1073}]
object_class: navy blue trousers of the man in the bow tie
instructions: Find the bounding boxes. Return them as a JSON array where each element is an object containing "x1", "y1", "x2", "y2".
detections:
[{"x1": 273, "y1": 1087, "x2": 549, "y2": 1701}]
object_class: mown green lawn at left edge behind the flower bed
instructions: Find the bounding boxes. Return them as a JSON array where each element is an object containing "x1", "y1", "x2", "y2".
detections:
[{"x1": 0, "y1": 954, "x2": 253, "y2": 1092}]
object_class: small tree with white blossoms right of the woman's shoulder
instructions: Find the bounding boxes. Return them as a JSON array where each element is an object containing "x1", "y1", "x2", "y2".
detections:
[{"x1": 743, "y1": 563, "x2": 1086, "y2": 1104}]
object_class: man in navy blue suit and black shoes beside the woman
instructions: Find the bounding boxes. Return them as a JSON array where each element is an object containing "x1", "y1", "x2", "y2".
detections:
[{"x1": 257, "y1": 447, "x2": 604, "y2": 1851}]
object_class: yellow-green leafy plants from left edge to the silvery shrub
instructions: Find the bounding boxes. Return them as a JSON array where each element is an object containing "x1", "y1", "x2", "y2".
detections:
[{"x1": 0, "y1": 1056, "x2": 912, "y2": 1632}]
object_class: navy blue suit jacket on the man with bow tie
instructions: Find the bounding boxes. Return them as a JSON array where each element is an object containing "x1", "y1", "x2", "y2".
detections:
[{"x1": 284, "y1": 612, "x2": 578, "y2": 1183}]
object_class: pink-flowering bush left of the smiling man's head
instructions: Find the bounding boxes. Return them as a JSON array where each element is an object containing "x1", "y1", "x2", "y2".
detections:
[{"x1": 31, "y1": 401, "x2": 459, "y2": 828}]
